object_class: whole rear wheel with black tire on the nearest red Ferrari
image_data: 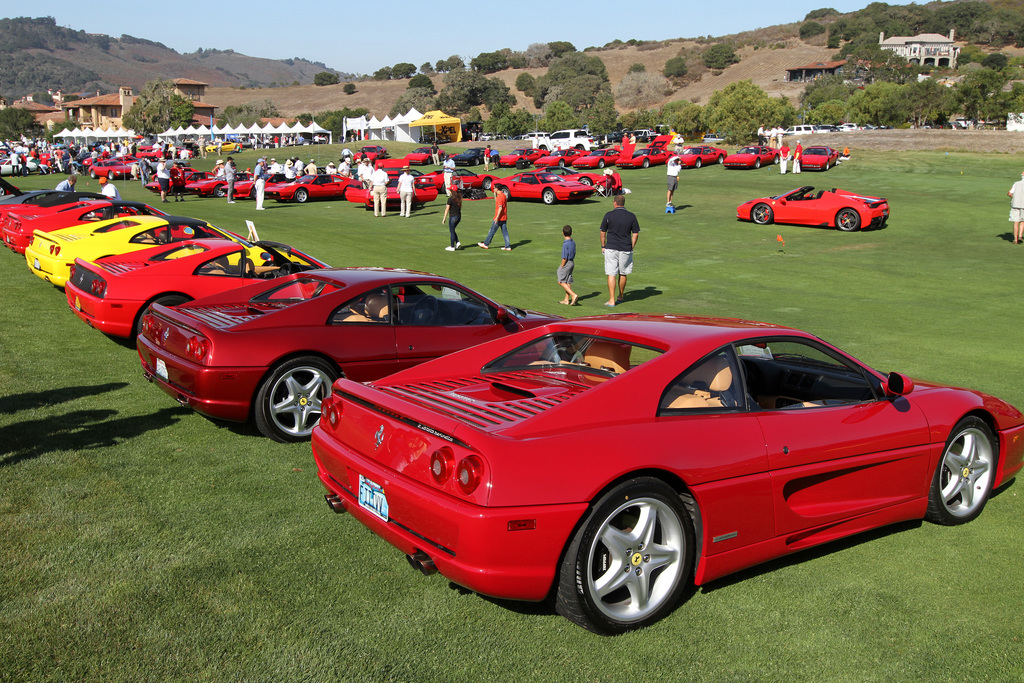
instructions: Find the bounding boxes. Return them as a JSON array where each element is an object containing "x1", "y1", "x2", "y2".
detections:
[{"x1": 555, "y1": 477, "x2": 694, "y2": 634}]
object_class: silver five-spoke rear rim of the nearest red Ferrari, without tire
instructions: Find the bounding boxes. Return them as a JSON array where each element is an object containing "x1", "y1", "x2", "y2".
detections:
[{"x1": 586, "y1": 498, "x2": 686, "y2": 624}]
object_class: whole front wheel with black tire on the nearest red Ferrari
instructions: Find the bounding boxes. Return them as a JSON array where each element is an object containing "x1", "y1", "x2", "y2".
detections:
[{"x1": 925, "y1": 417, "x2": 999, "y2": 526}]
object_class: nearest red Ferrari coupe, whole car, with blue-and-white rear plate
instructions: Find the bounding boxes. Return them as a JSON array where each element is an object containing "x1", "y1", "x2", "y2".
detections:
[{"x1": 312, "y1": 314, "x2": 1024, "y2": 633}]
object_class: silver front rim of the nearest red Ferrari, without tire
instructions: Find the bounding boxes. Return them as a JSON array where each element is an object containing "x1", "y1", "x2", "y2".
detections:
[{"x1": 939, "y1": 426, "x2": 995, "y2": 518}]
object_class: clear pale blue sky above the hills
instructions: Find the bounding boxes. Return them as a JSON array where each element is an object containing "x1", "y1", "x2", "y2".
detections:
[{"x1": 24, "y1": 0, "x2": 904, "y2": 74}]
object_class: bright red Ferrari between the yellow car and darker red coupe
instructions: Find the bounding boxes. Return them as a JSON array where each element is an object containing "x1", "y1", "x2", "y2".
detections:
[{"x1": 65, "y1": 240, "x2": 327, "y2": 337}]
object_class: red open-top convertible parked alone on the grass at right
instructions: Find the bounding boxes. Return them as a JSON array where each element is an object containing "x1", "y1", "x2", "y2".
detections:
[{"x1": 736, "y1": 185, "x2": 889, "y2": 232}]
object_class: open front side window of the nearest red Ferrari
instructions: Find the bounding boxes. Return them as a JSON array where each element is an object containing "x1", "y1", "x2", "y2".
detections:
[{"x1": 736, "y1": 339, "x2": 879, "y2": 410}]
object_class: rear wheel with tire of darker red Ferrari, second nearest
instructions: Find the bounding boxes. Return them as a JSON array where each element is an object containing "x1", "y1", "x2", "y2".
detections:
[{"x1": 253, "y1": 356, "x2": 338, "y2": 442}]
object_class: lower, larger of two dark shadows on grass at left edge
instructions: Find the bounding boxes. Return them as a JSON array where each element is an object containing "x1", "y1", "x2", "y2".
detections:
[{"x1": 0, "y1": 407, "x2": 191, "y2": 467}]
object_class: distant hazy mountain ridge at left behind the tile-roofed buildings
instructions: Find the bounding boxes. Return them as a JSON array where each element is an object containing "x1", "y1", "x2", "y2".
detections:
[{"x1": 0, "y1": 16, "x2": 347, "y2": 98}]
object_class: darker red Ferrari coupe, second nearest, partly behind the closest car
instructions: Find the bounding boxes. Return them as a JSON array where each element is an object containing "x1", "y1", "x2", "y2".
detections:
[{"x1": 137, "y1": 268, "x2": 555, "y2": 441}]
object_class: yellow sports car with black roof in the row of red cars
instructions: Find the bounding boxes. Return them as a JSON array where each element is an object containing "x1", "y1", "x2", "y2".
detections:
[{"x1": 25, "y1": 216, "x2": 243, "y2": 287}]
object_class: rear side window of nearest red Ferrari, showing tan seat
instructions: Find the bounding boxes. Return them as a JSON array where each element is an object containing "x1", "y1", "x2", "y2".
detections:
[{"x1": 658, "y1": 348, "x2": 746, "y2": 415}]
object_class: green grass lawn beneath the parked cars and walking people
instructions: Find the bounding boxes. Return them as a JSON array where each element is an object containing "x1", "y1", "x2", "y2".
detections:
[{"x1": 0, "y1": 143, "x2": 1024, "y2": 681}]
